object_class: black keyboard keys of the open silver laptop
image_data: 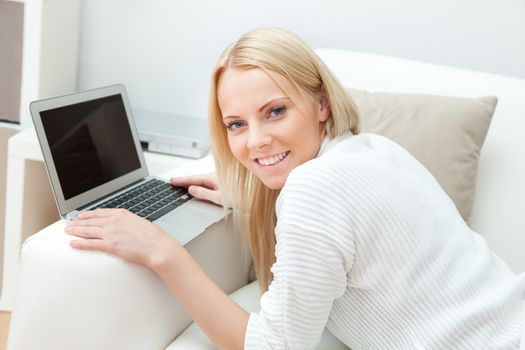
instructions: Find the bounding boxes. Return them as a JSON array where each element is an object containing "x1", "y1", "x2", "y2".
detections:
[{"x1": 92, "y1": 179, "x2": 192, "y2": 221}]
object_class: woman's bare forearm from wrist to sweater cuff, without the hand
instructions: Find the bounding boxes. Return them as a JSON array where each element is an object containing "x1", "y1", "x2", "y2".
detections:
[{"x1": 152, "y1": 241, "x2": 249, "y2": 349}]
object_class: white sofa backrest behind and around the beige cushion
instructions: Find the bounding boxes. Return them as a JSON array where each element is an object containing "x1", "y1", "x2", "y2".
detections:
[{"x1": 316, "y1": 49, "x2": 525, "y2": 272}]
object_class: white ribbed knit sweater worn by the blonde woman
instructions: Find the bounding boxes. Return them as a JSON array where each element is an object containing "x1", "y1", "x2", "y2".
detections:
[{"x1": 245, "y1": 134, "x2": 525, "y2": 350}]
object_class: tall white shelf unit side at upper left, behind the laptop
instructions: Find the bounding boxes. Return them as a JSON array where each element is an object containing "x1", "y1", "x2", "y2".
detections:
[{"x1": 9, "y1": 0, "x2": 81, "y2": 129}]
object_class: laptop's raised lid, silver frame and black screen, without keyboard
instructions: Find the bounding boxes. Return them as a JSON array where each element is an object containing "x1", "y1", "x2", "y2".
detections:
[{"x1": 30, "y1": 85, "x2": 148, "y2": 217}]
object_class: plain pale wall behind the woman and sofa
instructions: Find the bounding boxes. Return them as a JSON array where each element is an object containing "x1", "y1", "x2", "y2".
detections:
[{"x1": 78, "y1": 0, "x2": 525, "y2": 118}]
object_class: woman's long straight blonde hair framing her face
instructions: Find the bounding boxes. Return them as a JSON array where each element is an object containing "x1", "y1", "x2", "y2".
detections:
[{"x1": 209, "y1": 28, "x2": 359, "y2": 291}]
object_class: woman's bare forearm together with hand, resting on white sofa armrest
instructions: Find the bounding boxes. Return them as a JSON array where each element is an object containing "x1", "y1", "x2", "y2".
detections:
[{"x1": 65, "y1": 209, "x2": 249, "y2": 349}]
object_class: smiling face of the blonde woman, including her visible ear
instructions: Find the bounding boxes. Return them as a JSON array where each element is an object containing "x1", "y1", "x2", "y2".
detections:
[{"x1": 217, "y1": 68, "x2": 330, "y2": 189}]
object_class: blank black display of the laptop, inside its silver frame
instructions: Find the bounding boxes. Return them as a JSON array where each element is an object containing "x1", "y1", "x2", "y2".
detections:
[{"x1": 40, "y1": 94, "x2": 140, "y2": 200}]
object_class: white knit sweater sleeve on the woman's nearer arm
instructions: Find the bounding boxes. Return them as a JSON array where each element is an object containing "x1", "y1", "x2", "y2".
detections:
[{"x1": 244, "y1": 162, "x2": 354, "y2": 349}]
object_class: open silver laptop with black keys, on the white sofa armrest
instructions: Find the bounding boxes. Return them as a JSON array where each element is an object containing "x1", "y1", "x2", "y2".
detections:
[{"x1": 30, "y1": 85, "x2": 225, "y2": 245}]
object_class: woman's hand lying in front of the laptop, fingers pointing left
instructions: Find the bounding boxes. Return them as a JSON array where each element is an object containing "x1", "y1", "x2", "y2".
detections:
[{"x1": 65, "y1": 209, "x2": 179, "y2": 268}]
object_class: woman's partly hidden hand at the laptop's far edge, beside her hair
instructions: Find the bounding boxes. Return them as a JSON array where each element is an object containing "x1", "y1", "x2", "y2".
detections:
[{"x1": 170, "y1": 173, "x2": 223, "y2": 206}]
